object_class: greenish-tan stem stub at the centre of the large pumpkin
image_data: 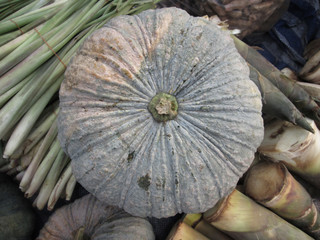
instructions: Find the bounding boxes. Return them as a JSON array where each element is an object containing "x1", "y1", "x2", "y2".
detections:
[{"x1": 148, "y1": 93, "x2": 178, "y2": 122}]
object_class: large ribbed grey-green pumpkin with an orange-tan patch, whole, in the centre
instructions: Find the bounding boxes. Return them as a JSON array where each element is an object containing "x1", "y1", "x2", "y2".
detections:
[{"x1": 58, "y1": 8, "x2": 263, "y2": 218}]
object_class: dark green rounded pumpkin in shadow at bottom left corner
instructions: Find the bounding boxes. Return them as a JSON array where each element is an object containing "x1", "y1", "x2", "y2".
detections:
[{"x1": 0, "y1": 174, "x2": 36, "y2": 240}]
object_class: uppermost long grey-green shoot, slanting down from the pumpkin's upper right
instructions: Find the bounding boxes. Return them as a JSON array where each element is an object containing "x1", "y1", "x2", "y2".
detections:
[{"x1": 231, "y1": 35, "x2": 320, "y2": 120}]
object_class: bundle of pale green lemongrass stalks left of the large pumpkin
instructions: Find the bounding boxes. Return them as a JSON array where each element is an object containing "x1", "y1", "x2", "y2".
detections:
[{"x1": 0, "y1": 0, "x2": 159, "y2": 210}]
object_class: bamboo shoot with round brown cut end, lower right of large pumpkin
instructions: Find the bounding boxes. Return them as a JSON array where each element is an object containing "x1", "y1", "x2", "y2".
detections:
[{"x1": 245, "y1": 161, "x2": 320, "y2": 239}]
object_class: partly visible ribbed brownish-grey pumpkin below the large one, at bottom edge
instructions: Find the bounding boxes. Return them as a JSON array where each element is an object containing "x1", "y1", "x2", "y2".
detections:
[{"x1": 37, "y1": 194, "x2": 155, "y2": 240}]
